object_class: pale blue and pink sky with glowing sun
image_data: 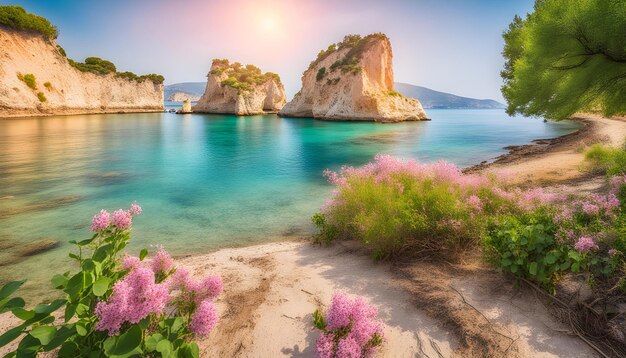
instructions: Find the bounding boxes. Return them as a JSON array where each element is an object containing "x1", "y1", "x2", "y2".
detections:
[{"x1": 2, "y1": 0, "x2": 534, "y2": 102}]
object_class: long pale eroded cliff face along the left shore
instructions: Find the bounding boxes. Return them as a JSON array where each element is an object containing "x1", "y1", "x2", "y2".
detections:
[{"x1": 0, "y1": 27, "x2": 163, "y2": 117}]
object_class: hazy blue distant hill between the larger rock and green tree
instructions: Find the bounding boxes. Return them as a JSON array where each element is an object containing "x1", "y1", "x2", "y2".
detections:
[{"x1": 394, "y1": 82, "x2": 506, "y2": 109}]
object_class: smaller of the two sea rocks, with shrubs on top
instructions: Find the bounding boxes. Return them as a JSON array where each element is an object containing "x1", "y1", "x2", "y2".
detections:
[{"x1": 192, "y1": 59, "x2": 286, "y2": 116}]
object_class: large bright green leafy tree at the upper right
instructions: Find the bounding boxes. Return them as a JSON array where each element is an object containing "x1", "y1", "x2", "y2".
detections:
[{"x1": 501, "y1": 0, "x2": 626, "y2": 120}]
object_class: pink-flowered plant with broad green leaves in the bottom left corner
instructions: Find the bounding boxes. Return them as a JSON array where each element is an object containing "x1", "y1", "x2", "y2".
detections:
[{"x1": 0, "y1": 204, "x2": 222, "y2": 357}]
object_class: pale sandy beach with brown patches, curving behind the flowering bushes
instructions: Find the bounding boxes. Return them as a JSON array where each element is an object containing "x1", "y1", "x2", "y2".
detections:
[{"x1": 0, "y1": 116, "x2": 626, "y2": 357}]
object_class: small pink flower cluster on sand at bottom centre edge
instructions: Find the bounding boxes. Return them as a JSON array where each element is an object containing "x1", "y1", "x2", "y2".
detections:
[{"x1": 313, "y1": 292, "x2": 383, "y2": 358}]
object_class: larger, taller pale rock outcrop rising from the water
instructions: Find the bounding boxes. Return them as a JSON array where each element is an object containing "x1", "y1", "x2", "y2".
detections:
[{"x1": 279, "y1": 34, "x2": 428, "y2": 122}]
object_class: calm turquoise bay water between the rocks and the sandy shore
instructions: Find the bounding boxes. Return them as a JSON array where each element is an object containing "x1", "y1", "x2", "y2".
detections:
[{"x1": 0, "y1": 110, "x2": 579, "y2": 291}]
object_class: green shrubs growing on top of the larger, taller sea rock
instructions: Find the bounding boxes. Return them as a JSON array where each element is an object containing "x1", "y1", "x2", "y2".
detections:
[{"x1": 307, "y1": 33, "x2": 389, "y2": 81}]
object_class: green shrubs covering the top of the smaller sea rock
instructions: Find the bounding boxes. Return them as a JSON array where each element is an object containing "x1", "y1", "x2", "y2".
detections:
[{"x1": 209, "y1": 59, "x2": 282, "y2": 94}]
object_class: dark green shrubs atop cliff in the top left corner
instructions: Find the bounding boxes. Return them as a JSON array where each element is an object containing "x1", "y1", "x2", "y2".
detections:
[{"x1": 0, "y1": 6, "x2": 59, "y2": 40}]
